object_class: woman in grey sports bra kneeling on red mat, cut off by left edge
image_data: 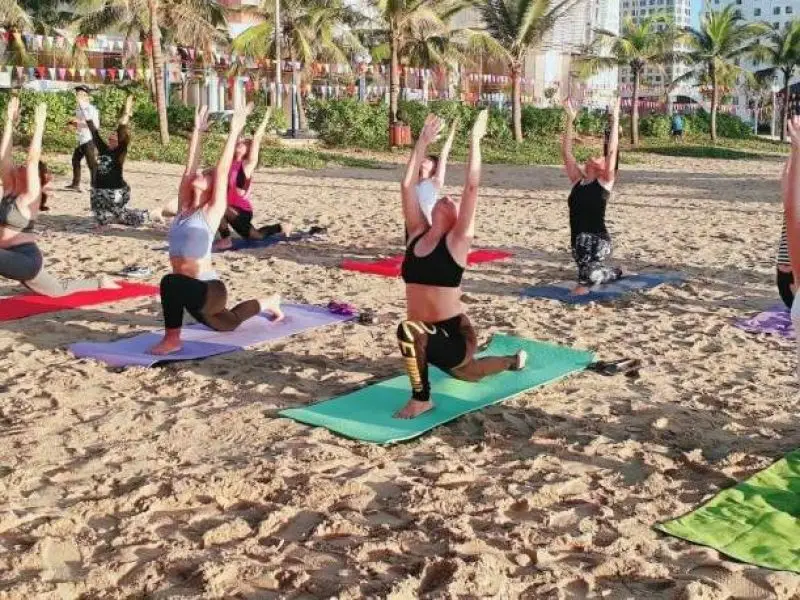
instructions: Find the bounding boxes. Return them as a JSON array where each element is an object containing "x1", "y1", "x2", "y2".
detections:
[{"x1": 0, "y1": 96, "x2": 119, "y2": 297}]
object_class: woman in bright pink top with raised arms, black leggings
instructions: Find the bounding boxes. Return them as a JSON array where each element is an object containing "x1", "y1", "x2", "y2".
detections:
[{"x1": 214, "y1": 109, "x2": 292, "y2": 250}]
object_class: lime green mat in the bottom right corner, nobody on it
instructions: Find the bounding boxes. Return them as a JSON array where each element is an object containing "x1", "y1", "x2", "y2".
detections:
[{"x1": 656, "y1": 449, "x2": 800, "y2": 573}]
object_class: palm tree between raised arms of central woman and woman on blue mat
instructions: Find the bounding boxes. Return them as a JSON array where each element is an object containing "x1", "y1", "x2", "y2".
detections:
[{"x1": 475, "y1": 0, "x2": 578, "y2": 142}]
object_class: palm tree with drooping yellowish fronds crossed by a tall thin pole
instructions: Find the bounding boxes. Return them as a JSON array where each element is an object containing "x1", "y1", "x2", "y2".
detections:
[{"x1": 232, "y1": 0, "x2": 363, "y2": 129}]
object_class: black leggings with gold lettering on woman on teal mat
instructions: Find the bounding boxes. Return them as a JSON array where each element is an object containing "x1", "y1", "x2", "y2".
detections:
[{"x1": 397, "y1": 314, "x2": 517, "y2": 402}]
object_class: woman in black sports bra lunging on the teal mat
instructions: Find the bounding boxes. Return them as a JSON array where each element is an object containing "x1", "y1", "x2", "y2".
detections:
[{"x1": 395, "y1": 110, "x2": 527, "y2": 419}]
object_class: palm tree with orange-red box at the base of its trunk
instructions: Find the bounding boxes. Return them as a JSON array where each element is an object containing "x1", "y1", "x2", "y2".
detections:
[{"x1": 367, "y1": 0, "x2": 468, "y2": 123}]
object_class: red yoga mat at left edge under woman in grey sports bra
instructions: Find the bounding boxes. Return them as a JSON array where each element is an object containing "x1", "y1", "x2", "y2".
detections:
[{"x1": 0, "y1": 281, "x2": 158, "y2": 321}]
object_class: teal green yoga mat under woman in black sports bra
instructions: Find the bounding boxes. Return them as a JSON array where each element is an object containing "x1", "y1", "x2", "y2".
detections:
[{"x1": 280, "y1": 335, "x2": 594, "y2": 444}]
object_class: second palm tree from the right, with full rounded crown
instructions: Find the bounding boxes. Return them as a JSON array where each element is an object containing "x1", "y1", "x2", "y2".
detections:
[{"x1": 673, "y1": 5, "x2": 766, "y2": 141}]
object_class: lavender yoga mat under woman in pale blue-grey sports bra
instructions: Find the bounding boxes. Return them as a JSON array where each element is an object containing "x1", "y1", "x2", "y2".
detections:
[{"x1": 69, "y1": 304, "x2": 352, "y2": 367}]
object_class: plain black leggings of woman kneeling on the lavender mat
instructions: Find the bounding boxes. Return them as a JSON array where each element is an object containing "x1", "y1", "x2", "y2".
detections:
[{"x1": 161, "y1": 273, "x2": 261, "y2": 331}]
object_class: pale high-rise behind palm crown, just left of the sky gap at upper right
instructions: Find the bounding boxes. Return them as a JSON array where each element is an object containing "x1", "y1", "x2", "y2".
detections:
[{"x1": 619, "y1": 0, "x2": 693, "y2": 98}]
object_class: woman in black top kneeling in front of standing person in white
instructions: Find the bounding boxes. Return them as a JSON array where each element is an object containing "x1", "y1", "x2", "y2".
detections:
[{"x1": 83, "y1": 96, "x2": 148, "y2": 227}]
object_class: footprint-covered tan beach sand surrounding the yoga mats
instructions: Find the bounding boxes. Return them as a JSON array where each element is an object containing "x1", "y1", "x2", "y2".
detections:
[{"x1": 0, "y1": 152, "x2": 800, "y2": 600}]
